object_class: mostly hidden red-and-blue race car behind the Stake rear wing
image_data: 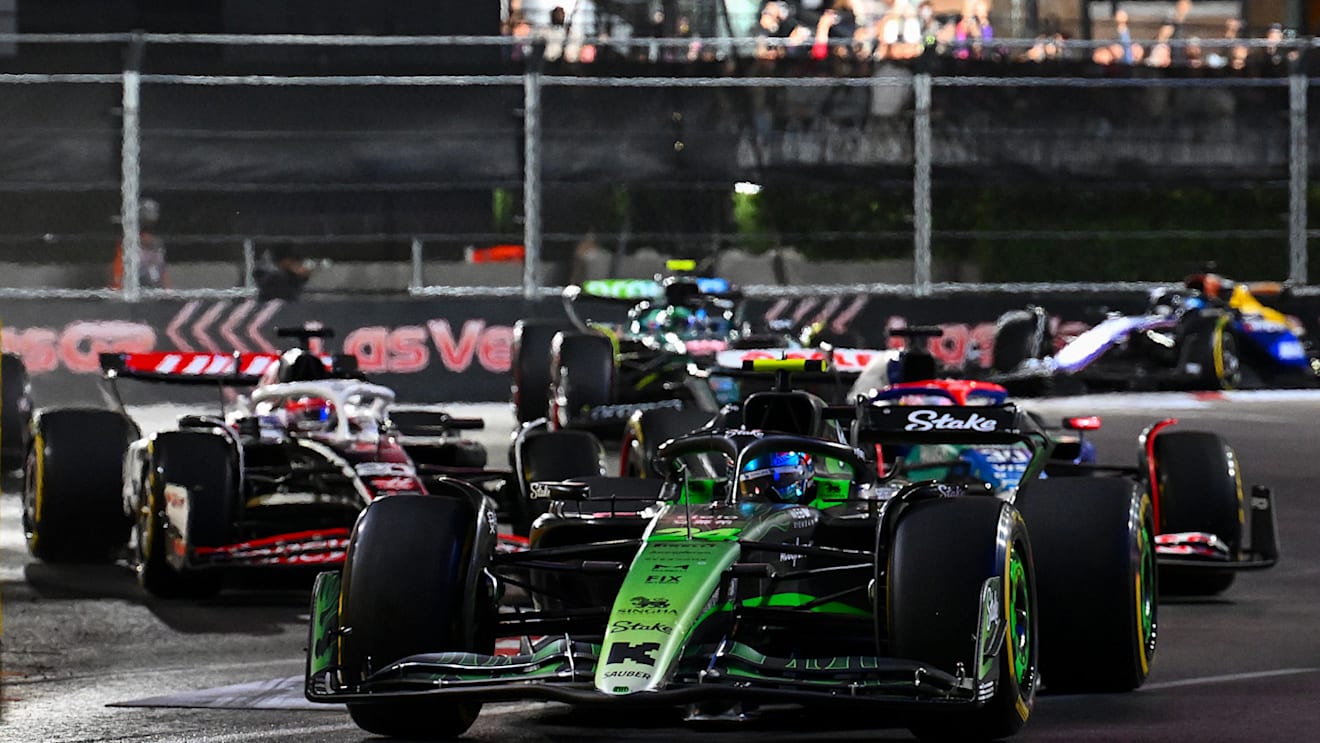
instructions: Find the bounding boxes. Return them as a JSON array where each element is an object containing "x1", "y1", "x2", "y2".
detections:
[{"x1": 869, "y1": 379, "x2": 1279, "y2": 595}]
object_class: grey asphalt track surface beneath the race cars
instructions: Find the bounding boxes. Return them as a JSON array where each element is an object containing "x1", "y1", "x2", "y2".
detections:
[{"x1": 0, "y1": 392, "x2": 1320, "y2": 743}]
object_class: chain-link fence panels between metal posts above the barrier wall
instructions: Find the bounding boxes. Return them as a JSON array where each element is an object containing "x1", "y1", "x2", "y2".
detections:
[{"x1": 0, "y1": 34, "x2": 1313, "y2": 300}]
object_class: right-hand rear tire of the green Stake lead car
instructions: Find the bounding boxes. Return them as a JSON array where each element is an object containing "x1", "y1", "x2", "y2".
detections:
[{"x1": 1016, "y1": 478, "x2": 1159, "y2": 692}]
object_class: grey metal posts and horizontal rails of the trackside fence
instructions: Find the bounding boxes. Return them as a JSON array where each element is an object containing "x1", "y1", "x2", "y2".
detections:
[{"x1": 0, "y1": 34, "x2": 1320, "y2": 301}]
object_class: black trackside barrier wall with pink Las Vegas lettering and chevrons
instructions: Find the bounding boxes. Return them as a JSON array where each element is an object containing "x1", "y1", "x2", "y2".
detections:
[{"x1": 0, "y1": 293, "x2": 1320, "y2": 405}]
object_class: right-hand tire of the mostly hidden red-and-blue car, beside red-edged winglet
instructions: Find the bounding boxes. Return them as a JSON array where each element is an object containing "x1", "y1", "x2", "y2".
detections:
[{"x1": 1152, "y1": 430, "x2": 1246, "y2": 595}]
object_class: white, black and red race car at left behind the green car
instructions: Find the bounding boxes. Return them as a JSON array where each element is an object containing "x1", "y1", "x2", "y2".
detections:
[{"x1": 22, "y1": 333, "x2": 507, "y2": 598}]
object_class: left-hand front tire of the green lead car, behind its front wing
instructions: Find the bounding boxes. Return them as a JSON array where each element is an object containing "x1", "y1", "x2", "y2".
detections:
[{"x1": 341, "y1": 495, "x2": 495, "y2": 739}]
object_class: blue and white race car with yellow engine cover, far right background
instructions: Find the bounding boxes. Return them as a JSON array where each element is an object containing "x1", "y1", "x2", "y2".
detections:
[{"x1": 991, "y1": 273, "x2": 1320, "y2": 393}]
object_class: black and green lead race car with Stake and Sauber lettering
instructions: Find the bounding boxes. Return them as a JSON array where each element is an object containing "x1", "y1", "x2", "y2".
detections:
[{"x1": 306, "y1": 358, "x2": 1155, "y2": 739}]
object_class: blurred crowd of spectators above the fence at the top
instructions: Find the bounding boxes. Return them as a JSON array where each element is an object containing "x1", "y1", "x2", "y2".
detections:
[{"x1": 504, "y1": 0, "x2": 1299, "y2": 70}]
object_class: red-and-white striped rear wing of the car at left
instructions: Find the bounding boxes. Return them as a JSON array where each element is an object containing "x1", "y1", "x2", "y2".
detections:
[{"x1": 100, "y1": 351, "x2": 358, "y2": 387}]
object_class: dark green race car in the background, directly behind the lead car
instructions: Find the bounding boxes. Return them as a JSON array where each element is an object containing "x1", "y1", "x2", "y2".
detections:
[{"x1": 511, "y1": 267, "x2": 888, "y2": 436}]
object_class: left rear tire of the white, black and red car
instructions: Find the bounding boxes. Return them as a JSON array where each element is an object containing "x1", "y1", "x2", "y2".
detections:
[{"x1": 22, "y1": 409, "x2": 136, "y2": 562}]
